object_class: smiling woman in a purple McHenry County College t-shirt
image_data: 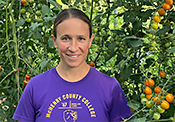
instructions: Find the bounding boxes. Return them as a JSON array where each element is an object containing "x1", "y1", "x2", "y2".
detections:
[{"x1": 13, "y1": 8, "x2": 131, "y2": 122}]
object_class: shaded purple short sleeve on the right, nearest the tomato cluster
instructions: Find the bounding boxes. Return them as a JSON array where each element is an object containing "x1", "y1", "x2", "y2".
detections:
[{"x1": 109, "y1": 82, "x2": 132, "y2": 122}]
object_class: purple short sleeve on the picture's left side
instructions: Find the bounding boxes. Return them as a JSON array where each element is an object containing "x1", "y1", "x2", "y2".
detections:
[{"x1": 13, "y1": 82, "x2": 35, "y2": 122}]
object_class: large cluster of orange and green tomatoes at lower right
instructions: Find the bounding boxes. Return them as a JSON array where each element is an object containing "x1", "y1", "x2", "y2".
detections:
[{"x1": 140, "y1": 71, "x2": 174, "y2": 120}]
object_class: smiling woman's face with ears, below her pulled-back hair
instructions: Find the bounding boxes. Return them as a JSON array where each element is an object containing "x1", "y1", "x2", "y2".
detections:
[{"x1": 52, "y1": 18, "x2": 94, "y2": 67}]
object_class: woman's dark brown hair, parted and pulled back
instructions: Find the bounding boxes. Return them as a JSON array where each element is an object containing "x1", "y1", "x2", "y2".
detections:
[{"x1": 53, "y1": 8, "x2": 92, "y2": 38}]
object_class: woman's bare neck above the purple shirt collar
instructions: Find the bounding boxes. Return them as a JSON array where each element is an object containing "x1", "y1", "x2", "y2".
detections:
[{"x1": 56, "y1": 64, "x2": 90, "y2": 82}]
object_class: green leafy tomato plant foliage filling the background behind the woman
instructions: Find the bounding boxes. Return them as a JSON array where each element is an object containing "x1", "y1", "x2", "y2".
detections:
[{"x1": 0, "y1": 0, "x2": 175, "y2": 122}]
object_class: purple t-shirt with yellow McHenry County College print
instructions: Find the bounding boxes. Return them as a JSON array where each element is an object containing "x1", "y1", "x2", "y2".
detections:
[{"x1": 13, "y1": 67, "x2": 132, "y2": 122}]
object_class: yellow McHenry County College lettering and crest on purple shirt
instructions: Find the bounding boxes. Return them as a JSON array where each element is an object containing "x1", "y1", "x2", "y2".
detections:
[{"x1": 46, "y1": 93, "x2": 96, "y2": 122}]
